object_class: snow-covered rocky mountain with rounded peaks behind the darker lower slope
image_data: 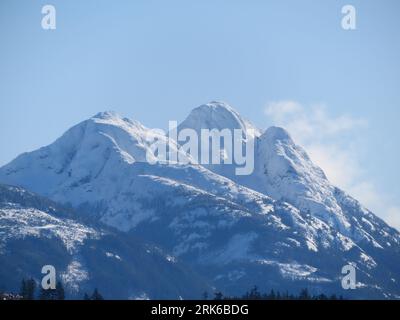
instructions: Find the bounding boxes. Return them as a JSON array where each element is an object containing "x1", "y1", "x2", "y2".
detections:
[{"x1": 0, "y1": 102, "x2": 400, "y2": 298}]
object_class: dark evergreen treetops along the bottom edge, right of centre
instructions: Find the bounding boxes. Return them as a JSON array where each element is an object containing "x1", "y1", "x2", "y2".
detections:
[{"x1": 203, "y1": 286, "x2": 343, "y2": 300}]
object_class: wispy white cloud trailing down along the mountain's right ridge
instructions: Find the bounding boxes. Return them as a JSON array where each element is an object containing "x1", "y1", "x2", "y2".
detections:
[{"x1": 265, "y1": 101, "x2": 400, "y2": 230}]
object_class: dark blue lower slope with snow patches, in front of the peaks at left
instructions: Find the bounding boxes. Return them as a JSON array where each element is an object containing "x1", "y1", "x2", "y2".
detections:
[{"x1": 0, "y1": 185, "x2": 208, "y2": 299}]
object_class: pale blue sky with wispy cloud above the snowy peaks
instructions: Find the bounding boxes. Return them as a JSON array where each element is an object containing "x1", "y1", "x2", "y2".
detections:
[{"x1": 0, "y1": 0, "x2": 400, "y2": 226}]
